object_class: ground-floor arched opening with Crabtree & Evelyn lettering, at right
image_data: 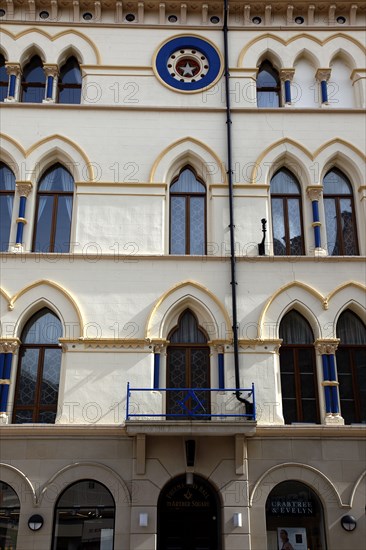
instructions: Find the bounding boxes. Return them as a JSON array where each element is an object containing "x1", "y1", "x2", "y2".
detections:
[{"x1": 266, "y1": 480, "x2": 327, "y2": 550}]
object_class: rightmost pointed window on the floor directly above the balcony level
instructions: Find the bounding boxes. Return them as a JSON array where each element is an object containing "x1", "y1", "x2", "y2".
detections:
[{"x1": 323, "y1": 168, "x2": 358, "y2": 256}]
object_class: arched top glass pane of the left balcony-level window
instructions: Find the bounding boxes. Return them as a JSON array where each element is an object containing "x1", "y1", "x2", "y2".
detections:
[{"x1": 21, "y1": 308, "x2": 62, "y2": 344}]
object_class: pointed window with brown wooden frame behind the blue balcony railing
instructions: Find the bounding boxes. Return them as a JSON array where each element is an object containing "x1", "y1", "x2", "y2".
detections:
[{"x1": 166, "y1": 309, "x2": 210, "y2": 419}]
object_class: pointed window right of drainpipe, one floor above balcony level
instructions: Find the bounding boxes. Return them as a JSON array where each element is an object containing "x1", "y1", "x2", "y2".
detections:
[{"x1": 270, "y1": 168, "x2": 304, "y2": 256}]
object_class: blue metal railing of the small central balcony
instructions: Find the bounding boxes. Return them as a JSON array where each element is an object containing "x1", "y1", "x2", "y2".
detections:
[{"x1": 126, "y1": 382, "x2": 256, "y2": 420}]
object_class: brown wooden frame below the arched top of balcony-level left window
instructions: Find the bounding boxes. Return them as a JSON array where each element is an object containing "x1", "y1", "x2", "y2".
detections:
[{"x1": 13, "y1": 344, "x2": 60, "y2": 423}]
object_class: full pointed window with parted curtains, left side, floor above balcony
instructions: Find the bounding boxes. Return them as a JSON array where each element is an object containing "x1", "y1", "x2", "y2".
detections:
[{"x1": 33, "y1": 163, "x2": 74, "y2": 252}]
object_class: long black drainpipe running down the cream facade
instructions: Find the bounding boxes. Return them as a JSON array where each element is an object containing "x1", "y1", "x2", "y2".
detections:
[{"x1": 223, "y1": 0, "x2": 246, "y2": 412}]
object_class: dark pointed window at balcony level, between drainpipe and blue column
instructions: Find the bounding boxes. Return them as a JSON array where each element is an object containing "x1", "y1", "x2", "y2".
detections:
[{"x1": 279, "y1": 310, "x2": 319, "y2": 424}]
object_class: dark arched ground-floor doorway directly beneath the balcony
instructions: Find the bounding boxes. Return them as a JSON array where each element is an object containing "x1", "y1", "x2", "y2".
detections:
[{"x1": 158, "y1": 475, "x2": 221, "y2": 550}]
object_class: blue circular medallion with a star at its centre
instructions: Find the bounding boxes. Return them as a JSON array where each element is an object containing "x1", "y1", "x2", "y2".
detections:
[{"x1": 155, "y1": 36, "x2": 221, "y2": 92}]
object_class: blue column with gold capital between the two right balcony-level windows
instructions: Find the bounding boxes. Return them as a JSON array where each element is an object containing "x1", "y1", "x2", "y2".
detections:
[{"x1": 315, "y1": 338, "x2": 344, "y2": 425}]
